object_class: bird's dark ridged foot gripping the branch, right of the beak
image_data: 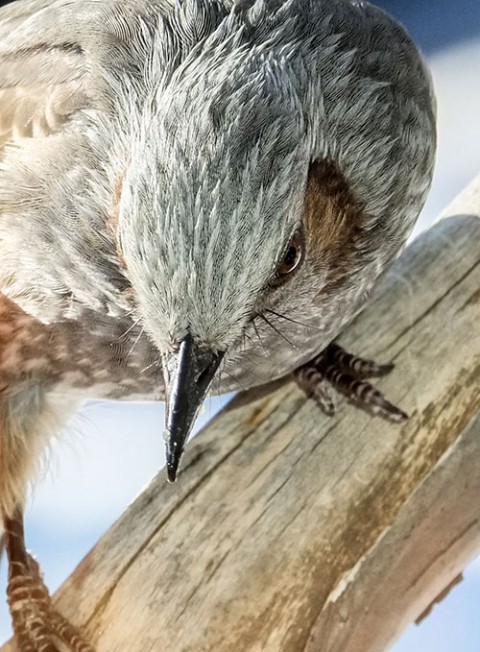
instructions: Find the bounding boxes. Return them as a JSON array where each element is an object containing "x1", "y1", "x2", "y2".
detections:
[{"x1": 295, "y1": 343, "x2": 408, "y2": 422}]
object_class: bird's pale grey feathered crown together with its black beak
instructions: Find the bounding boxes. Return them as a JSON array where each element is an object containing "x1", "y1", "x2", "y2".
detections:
[{"x1": 115, "y1": 53, "x2": 308, "y2": 480}]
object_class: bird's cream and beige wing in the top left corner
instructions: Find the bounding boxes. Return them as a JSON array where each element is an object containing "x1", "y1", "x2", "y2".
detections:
[{"x1": 0, "y1": 0, "x2": 99, "y2": 156}]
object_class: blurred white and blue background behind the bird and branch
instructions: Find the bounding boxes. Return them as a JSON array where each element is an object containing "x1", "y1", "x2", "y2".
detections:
[{"x1": 0, "y1": 0, "x2": 480, "y2": 652}]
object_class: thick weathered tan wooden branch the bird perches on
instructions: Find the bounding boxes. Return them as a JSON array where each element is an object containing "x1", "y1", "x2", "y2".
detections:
[{"x1": 3, "y1": 178, "x2": 480, "y2": 652}]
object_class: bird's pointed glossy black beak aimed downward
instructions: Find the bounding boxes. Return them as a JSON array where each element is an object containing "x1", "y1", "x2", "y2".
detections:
[{"x1": 163, "y1": 334, "x2": 223, "y2": 482}]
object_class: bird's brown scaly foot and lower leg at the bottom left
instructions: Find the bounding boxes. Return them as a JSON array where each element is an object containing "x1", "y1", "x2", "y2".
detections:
[{"x1": 4, "y1": 517, "x2": 94, "y2": 652}]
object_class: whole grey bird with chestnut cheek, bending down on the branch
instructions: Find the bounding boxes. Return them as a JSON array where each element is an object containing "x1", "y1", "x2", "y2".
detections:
[{"x1": 0, "y1": 0, "x2": 436, "y2": 652}]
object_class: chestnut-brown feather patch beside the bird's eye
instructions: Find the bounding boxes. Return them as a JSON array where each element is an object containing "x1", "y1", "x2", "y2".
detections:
[{"x1": 304, "y1": 160, "x2": 365, "y2": 289}]
